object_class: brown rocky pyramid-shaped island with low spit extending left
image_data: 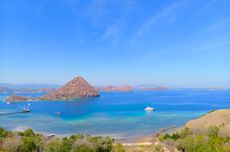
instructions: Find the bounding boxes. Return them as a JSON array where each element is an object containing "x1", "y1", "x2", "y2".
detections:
[{"x1": 6, "y1": 76, "x2": 99, "y2": 102}]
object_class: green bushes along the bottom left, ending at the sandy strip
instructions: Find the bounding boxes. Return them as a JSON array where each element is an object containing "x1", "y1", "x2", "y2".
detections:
[{"x1": 0, "y1": 127, "x2": 124, "y2": 152}]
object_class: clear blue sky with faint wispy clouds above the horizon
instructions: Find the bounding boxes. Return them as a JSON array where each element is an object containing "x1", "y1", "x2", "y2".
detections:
[{"x1": 0, "y1": 0, "x2": 230, "y2": 87}]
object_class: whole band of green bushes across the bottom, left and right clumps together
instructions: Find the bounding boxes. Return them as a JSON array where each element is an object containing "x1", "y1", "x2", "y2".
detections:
[{"x1": 0, "y1": 126, "x2": 230, "y2": 152}]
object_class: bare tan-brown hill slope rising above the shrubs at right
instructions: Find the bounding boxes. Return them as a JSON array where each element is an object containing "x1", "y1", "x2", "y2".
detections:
[{"x1": 185, "y1": 109, "x2": 230, "y2": 135}]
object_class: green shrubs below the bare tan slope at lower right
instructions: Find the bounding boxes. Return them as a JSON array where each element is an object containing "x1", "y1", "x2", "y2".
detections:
[{"x1": 159, "y1": 126, "x2": 230, "y2": 152}]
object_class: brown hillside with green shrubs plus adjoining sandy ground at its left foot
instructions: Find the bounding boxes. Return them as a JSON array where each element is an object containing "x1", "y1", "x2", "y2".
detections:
[{"x1": 125, "y1": 109, "x2": 230, "y2": 152}]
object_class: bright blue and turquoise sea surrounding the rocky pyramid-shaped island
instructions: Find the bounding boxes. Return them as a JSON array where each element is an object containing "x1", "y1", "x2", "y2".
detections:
[{"x1": 0, "y1": 90, "x2": 230, "y2": 141}]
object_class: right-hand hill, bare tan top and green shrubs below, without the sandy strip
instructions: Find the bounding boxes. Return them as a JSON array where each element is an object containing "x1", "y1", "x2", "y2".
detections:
[{"x1": 158, "y1": 109, "x2": 230, "y2": 152}]
